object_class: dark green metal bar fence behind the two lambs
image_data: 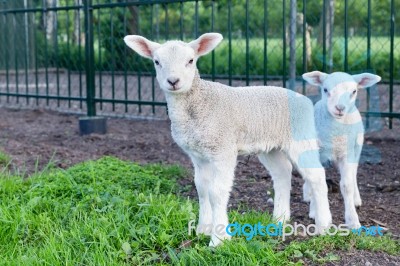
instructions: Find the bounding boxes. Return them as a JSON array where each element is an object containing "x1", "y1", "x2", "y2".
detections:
[{"x1": 0, "y1": 0, "x2": 400, "y2": 127}]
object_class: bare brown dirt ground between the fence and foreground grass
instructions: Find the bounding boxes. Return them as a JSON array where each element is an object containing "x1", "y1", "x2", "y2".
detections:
[{"x1": 0, "y1": 107, "x2": 400, "y2": 265}]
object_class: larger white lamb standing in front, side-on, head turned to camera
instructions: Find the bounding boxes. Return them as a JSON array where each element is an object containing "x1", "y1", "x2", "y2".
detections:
[{"x1": 124, "y1": 33, "x2": 331, "y2": 246}]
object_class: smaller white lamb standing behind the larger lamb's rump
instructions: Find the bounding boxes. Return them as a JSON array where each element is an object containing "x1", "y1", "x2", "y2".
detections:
[{"x1": 303, "y1": 71, "x2": 381, "y2": 228}]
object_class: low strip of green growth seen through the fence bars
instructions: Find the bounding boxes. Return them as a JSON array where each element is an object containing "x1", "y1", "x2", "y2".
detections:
[{"x1": 38, "y1": 37, "x2": 400, "y2": 79}]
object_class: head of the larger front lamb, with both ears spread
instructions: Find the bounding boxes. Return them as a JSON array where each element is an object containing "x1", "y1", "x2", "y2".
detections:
[{"x1": 124, "y1": 33, "x2": 222, "y2": 93}]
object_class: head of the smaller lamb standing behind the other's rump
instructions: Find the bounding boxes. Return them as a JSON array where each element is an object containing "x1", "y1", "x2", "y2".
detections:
[{"x1": 303, "y1": 71, "x2": 381, "y2": 119}]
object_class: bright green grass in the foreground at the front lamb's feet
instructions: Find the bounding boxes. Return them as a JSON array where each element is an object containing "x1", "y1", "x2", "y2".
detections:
[{"x1": 0, "y1": 157, "x2": 400, "y2": 265}]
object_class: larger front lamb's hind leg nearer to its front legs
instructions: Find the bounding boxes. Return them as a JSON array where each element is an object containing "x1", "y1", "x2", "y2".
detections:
[{"x1": 258, "y1": 150, "x2": 292, "y2": 222}]
